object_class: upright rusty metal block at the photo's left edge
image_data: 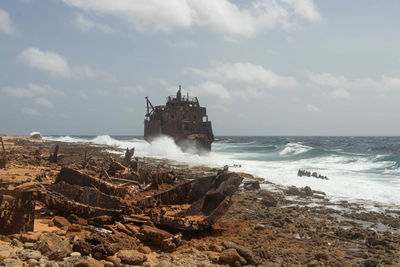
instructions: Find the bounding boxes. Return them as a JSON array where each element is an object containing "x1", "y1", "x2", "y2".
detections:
[{"x1": 0, "y1": 190, "x2": 35, "y2": 234}]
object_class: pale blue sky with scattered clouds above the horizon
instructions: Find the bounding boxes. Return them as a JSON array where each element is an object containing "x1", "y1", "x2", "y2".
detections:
[{"x1": 0, "y1": 0, "x2": 400, "y2": 136}]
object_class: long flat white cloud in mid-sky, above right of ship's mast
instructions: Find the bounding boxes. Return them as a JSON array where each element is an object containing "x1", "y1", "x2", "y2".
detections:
[{"x1": 187, "y1": 62, "x2": 298, "y2": 88}]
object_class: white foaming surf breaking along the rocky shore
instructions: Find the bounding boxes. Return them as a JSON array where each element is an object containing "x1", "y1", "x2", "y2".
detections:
[{"x1": 45, "y1": 135, "x2": 400, "y2": 205}]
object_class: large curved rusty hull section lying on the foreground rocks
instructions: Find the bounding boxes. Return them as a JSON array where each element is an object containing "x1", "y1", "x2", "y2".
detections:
[{"x1": 41, "y1": 164, "x2": 242, "y2": 230}]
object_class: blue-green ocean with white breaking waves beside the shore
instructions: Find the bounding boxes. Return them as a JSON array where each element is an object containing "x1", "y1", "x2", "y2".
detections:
[{"x1": 44, "y1": 135, "x2": 400, "y2": 208}]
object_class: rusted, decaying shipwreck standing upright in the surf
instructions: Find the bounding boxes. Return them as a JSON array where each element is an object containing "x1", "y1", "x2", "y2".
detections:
[{"x1": 144, "y1": 86, "x2": 214, "y2": 153}]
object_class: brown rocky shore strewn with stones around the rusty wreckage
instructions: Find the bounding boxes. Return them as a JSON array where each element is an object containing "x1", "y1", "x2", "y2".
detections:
[{"x1": 0, "y1": 137, "x2": 400, "y2": 267}]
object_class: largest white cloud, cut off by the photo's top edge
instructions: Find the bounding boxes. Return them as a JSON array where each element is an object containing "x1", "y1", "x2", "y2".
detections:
[{"x1": 62, "y1": 0, "x2": 321, "y2": 37}]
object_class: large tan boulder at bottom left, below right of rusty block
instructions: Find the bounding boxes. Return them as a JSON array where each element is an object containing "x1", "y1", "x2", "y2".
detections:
[{"x1": 36, "y1": 233, "x2": 72, "y2": 260}]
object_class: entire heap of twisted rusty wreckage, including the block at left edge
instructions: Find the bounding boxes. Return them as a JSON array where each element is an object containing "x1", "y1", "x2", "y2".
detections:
[{"x1": 0, "y1": 149, "x2": 243, "y2": 241}]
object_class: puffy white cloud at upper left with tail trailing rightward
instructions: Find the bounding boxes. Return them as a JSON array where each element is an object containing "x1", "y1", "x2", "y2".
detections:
[{"x1": 18, "y1": 48, "x2": 115, "y2": 80}]
